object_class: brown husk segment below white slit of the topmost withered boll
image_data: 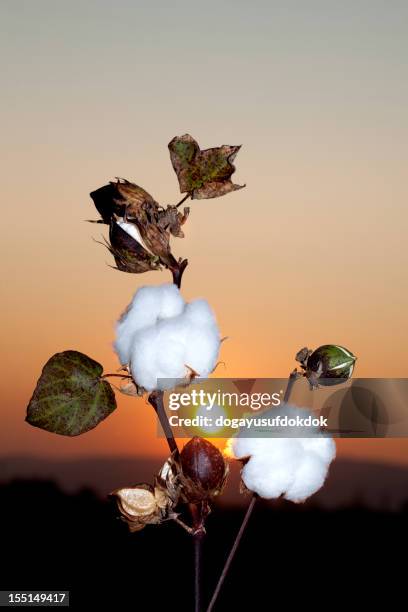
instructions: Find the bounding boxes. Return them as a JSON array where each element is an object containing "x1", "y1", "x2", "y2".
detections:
[{"x1": 107, "y1": 219, "x2": 160, "y2": 274}]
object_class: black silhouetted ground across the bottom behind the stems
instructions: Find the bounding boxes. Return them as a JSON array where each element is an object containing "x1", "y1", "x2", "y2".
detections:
[{"x1": 0, "y1": 480, "x2": 408, "y2": 612}]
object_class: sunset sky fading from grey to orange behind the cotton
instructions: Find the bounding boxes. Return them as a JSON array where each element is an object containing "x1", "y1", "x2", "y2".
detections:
[{"x1": 0, "y1": 0, "x2": 408, "y2": 463}]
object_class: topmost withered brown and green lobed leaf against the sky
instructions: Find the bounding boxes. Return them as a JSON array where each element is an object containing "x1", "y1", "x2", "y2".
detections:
[{"x1": 169, "y1": 134, "x2": 245, "y2": 200}]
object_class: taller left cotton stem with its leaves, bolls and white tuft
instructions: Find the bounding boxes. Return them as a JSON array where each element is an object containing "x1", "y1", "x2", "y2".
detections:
[{"x1": 26, "y1": 134, "x2": 245, "y2": 611}]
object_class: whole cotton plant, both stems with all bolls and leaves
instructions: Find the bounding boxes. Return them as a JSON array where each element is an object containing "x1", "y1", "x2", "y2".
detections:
[{"x1": 26, "y1": 134, "x2": 355, "y2": 612}]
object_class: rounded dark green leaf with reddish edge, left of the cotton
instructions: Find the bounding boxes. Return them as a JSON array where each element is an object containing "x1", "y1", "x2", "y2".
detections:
[{"x1": 26, "y1": 351, "x2": 116, "y2": 436}]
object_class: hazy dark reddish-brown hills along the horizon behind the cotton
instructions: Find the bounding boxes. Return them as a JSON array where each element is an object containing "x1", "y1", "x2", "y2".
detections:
[{"x1": 0, "y1": 455, "x2": 408, "y2": 510}]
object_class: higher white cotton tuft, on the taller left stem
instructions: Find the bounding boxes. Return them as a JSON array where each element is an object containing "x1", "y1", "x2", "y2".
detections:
[{"x1": 114, "y1": 283, "x2": 220, "y2": 391}]
